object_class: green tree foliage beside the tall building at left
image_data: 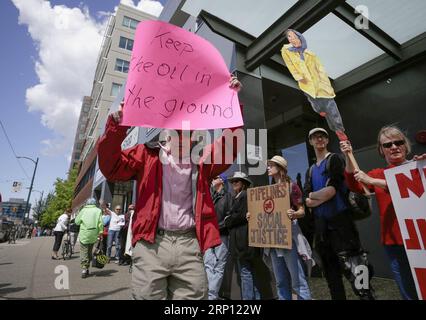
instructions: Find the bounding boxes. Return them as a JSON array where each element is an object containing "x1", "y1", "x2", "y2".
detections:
[{"x1": 39, "y1": 168, "x2": 77, "y2": 228}]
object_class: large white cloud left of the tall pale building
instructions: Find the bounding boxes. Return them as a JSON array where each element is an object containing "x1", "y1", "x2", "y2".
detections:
[{"x1": 12, "y1": 0, "x2": 105, "y2": 156}]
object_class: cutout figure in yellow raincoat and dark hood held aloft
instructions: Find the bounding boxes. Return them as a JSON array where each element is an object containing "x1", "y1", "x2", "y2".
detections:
[{"x1": 281, "y1": 29, "x2": 348, "y2": 140}]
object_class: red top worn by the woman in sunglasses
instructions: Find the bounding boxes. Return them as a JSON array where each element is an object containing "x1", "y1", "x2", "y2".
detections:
[{"x1": 345, "y1": 166, "x2": 404, "y2": 245}]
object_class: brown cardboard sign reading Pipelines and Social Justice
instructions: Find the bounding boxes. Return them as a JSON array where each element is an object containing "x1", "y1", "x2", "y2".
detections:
[{"x1": 247, "y1": 183, "x2": 292, "y2": 249}]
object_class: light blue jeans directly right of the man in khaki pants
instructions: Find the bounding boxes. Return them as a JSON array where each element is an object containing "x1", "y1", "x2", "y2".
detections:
[{"x1": 204, "y1": 236, "x2": 229, "y2": 300}]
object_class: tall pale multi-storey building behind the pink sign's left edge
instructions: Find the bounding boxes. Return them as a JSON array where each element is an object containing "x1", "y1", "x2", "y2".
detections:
[{"x1": 72, "y1": 4, "x2": 156, "y2": 211}]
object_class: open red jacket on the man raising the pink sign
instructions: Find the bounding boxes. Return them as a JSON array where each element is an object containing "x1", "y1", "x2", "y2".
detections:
[{"x1": 97, "y1": 116, "x2": 237, "y2": 253}]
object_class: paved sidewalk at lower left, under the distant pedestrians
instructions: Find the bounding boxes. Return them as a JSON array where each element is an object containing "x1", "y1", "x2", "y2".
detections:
[{"x1": 0, "y1": 237, "x2": 131, "y2": 300}]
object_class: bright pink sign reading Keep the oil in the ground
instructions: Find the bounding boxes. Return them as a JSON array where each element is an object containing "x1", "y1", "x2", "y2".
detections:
[{"x1": 123, "y1": 21, "x2": 243, "y2": 129}]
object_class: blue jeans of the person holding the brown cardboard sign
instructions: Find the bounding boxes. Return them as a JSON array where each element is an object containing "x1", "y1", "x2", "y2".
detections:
[{"x1": 270, "y1": 241, "x2": 312, "y2": 300}]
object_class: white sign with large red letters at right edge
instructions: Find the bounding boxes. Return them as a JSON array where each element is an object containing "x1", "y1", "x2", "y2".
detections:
[{"x1": 385, "y1": 161, "x2": 426, "y2": 300}]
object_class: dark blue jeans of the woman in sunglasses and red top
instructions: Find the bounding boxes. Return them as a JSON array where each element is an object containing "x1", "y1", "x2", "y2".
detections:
[{"x1": 383, "y1": 245, "x2": 418, "y2": 300}]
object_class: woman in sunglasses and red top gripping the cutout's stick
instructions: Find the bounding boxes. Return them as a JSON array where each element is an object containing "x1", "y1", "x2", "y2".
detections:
[{"x1": 340, "y1": 126, "x2": 426, "y2": 300}]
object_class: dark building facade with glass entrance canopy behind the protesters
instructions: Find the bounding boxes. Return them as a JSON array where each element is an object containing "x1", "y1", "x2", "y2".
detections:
[{"x1": 159, "y1": 0, "x2": 426, "y2": 277}]
